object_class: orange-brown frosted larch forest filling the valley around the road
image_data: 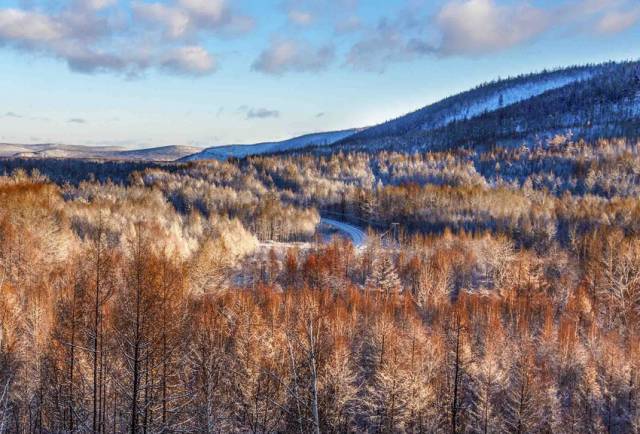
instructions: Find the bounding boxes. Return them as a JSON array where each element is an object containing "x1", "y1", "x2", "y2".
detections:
[{"x1": 0, "y1": 136, "x2": 640, "y2": 434}]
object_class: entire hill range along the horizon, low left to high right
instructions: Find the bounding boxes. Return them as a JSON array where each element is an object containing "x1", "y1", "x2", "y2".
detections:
[{"x1": 0, "y1": 61, "x2": 640, "y2": 161}]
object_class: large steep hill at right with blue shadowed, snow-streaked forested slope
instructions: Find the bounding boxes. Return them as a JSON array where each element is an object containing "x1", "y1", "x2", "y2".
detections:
[{"x1": 308, "y1": 62, "x2": 640, "y2": 152}]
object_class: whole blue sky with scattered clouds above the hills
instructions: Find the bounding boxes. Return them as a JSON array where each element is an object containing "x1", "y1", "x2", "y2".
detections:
[{"x1": 0, "y1": 0, "x2": 640, "y2": 148}]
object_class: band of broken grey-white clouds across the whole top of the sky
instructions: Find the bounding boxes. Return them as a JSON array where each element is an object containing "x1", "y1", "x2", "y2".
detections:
[{"x1": 0, "y1": 0, "x2": 640, "y2": 76}]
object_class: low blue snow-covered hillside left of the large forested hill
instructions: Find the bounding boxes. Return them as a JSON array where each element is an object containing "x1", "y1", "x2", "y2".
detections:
[{"x1": 182, "y1": 129, "x2": 358, "y2": 161}]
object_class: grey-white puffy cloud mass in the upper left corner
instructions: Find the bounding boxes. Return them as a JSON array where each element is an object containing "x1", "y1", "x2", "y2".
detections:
[{"x1": 0, "y1": 0, "x2": 244, "y2": 76}]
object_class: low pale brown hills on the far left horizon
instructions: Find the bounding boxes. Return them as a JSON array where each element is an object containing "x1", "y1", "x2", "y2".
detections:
[{"x1": 0, "y1": 143, "x2": 201, "y2": 161}]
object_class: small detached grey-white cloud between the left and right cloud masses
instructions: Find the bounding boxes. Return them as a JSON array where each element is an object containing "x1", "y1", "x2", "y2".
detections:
[{"x1": 252, "y1": 39, "x2": 335, "y2": 75}]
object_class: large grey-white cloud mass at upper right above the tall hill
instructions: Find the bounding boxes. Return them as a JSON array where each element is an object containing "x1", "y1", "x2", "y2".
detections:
[{"x1": 345, "y1": 0, "x2": 640, "y2": 71}]
